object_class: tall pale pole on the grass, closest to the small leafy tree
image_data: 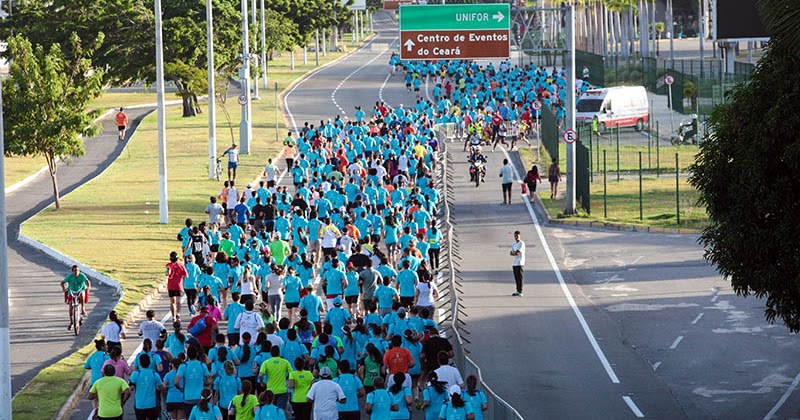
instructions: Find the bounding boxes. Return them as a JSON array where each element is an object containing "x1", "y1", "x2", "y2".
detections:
[{"x1": 154, "y1": 0, "x2": 169, "y2": 225}]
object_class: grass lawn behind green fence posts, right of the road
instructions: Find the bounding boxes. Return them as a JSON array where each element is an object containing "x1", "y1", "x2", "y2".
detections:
[{"x1": 520, "y1": 146, "x2": 708, "y2": 229}]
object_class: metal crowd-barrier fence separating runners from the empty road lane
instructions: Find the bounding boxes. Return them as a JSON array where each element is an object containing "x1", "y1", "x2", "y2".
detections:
[{"x1": 434, "y1": 124, "x2": 523, "y2": 420}]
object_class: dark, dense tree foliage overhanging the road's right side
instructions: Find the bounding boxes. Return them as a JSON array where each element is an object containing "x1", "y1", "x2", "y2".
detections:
[{"x1": 690, "y1": 0, "x2": 800, "y2": 332}]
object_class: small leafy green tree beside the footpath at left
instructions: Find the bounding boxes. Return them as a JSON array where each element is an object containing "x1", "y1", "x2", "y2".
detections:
[{"x1": 3, "y1": 33, "x2": 103, "y2": 209}]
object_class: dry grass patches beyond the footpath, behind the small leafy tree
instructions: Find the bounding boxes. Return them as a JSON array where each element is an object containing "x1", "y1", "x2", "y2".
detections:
[{"x1": 5, "y1": 92, "x2": 161, "y2": 188}]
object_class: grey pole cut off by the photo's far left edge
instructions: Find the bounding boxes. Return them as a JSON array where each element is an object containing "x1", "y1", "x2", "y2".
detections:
[{"x1": 0, "y1": 69, "x2": 11, "y2": 419}]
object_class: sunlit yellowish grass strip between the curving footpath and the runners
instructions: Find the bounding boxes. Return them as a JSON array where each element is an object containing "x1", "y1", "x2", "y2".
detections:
[{"x1": 13, "y1": 33, "x2": 372, "y2": 420}]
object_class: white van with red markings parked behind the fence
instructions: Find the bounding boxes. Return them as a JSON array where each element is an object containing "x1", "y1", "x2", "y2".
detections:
[{"x1": 575, "y1": 86, "x2": 650, "y2": 131}]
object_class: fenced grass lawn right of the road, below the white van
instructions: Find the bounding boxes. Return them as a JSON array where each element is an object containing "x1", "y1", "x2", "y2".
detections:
[{"x1": 520, "y1": 144, "x2": 708, "y2": 229}]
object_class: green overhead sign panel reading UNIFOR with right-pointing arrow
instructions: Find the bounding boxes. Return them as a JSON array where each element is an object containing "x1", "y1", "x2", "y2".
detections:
[{"x1": 400, "y1": 3, "x2": 511, "y2": 32}]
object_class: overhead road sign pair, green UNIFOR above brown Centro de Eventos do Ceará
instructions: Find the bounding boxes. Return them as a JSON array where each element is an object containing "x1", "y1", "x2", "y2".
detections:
[{"x1": 399, "y1": 3, "x2": 511, "y2": 60}]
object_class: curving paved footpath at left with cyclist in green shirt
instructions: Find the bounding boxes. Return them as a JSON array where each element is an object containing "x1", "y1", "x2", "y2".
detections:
[{"x1": 6, "y1": 108, "x2": 153, "y2": 395}]
